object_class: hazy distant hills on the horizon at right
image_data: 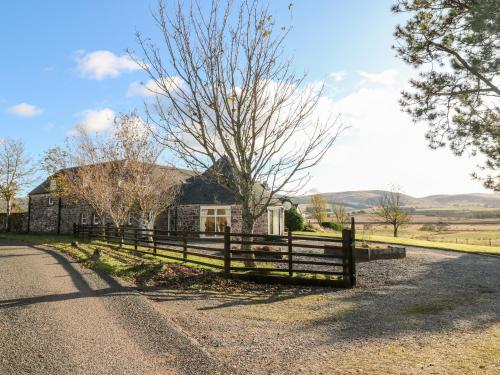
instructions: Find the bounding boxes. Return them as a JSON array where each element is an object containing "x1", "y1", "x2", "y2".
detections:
[{"x1": 293, "y1": 190, "x2": 500, "y2": 209}]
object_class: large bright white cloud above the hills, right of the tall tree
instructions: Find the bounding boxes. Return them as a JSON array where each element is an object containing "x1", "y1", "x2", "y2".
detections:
[{"x1": 296, "y1": 74, "x2": 485, "y2": 196}]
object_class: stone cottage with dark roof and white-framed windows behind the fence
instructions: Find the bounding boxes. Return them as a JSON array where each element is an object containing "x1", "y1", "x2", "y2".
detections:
[{"x1": 28, "y1": 163, "x2": 284, "y2": 236}]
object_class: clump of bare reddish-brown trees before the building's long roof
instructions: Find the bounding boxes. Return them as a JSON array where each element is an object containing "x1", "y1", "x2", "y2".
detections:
[{"x1": 42, "y1": 113, "x2": 179, "y2": 232}]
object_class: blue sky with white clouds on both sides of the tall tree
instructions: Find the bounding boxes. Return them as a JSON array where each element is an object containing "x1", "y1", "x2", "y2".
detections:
[{"x1": 0, "y1": 0, "x2": 487, "y2": 197}]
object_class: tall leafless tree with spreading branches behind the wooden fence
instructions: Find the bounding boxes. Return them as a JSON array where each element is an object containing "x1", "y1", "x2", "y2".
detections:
[{"x1": 130, "y1": 0, "x2": 341, "y2": 241}]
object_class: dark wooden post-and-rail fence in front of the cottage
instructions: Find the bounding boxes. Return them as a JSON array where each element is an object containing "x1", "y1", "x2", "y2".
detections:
[{"x1": 73, "y1": 222, "x2": 356, "y2": 288}]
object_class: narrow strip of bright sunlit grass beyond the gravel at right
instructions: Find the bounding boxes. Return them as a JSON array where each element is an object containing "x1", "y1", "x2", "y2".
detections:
[{"x1": 295, "y1": 232, "x2": 500, "y2": 255}]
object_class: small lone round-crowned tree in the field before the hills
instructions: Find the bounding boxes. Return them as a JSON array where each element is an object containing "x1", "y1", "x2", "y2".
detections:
[{"x1": 373, "y1": 187, "x2": 411, "y2": 237}]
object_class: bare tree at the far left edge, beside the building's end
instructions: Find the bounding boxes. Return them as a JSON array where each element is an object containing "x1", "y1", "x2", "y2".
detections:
[{"x1": 0, "y1": 139, "x2": 34, "y2": 232}]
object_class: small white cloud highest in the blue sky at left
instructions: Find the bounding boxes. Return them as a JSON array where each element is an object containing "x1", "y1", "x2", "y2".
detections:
[{"x1": 76, "y1": 50, "x2": 141, "y2": 80}]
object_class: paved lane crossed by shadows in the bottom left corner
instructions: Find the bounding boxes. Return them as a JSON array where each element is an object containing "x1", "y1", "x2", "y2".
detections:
[{"x1": 0, "y1": 241, "x2": 225, "y2": 374}]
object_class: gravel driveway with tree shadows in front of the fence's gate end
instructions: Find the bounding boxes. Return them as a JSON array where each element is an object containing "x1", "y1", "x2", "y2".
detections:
[{"x1": 144, "y1": 248, "x2": 500, "y2": 374}]
